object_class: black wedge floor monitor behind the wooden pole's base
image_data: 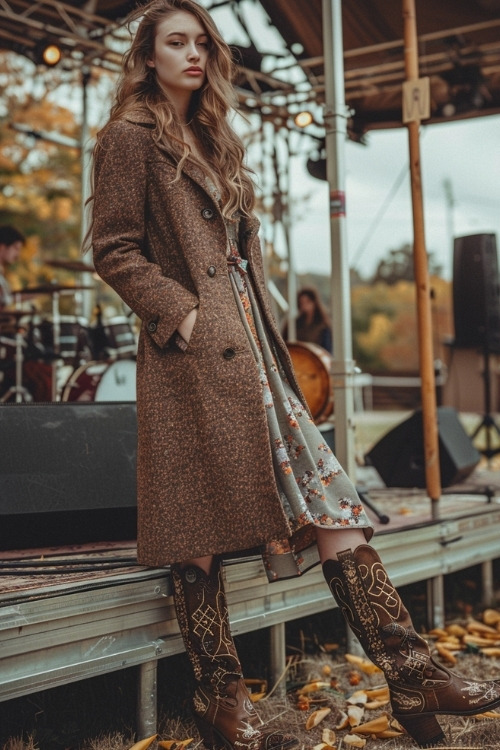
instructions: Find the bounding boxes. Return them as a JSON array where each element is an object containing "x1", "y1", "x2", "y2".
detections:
[{"x1": 365, "y1": 406, "x2": 481, "y2": 488}]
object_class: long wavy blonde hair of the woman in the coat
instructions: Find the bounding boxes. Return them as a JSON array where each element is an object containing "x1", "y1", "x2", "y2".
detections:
[{"x1": 94, "y1": 0, "x2": 255, "y2": 219}]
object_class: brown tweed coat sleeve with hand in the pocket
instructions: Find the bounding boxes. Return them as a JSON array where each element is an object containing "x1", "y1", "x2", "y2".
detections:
[{"x1": 92, "y1": 121, "x2": 198, "y2": 347}]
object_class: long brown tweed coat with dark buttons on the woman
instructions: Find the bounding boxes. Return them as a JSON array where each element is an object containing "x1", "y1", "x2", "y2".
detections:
[{"x1": 93, "y1": 115, "x2": 306, "y2": 566}]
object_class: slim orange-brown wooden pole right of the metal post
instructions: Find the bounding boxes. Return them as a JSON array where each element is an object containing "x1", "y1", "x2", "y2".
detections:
[{"x1": 403, "y1": 0, "x2": 441, "y2": 508}]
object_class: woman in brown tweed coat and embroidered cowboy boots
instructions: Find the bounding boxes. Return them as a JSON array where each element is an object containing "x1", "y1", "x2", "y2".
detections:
[{"x1": 92, "y1": 0, "x2": 500, "y2": 750}]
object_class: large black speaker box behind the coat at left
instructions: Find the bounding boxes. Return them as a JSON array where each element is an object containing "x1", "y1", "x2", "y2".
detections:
[{"x1": 0, "y1": 402, "x2": 137, "y2": 550}]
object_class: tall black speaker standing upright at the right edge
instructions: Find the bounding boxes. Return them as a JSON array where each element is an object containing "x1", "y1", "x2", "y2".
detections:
[{"x1": 453, "y1": 234, "x2": 500, "y2": 351}]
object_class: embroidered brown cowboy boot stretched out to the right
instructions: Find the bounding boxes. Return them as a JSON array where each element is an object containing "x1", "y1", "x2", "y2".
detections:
[{"x1": 323, "y1": 545, "x2": 500, "y2": 747}]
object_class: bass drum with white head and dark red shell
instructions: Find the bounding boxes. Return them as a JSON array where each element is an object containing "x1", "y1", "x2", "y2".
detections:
[{"x1": 61, "y1": 359, "x2": 136, "y2": 401}]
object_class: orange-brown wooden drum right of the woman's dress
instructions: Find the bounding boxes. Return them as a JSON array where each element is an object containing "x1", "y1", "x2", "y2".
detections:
[{"x1": 287, "y1": 341, "x2": 333, "y2": 424}]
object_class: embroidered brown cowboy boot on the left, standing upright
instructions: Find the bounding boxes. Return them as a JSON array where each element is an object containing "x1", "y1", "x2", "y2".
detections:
[{"x1": 172, "y1": 560, "x2": 299, "y2": 750}]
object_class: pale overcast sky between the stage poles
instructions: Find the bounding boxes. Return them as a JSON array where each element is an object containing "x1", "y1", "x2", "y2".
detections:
[{"x1": 292, "y1": 116, "x2": 500, "y2": 278}]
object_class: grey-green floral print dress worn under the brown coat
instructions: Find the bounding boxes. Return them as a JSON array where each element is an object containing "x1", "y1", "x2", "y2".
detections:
[{"x1": 226, "y1": 214, "x2": 373, "y2": 581}]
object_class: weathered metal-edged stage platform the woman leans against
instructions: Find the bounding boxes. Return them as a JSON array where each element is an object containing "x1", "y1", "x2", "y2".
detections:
[{"x1": 0, "y1": 467, "x2": 500, "y2": 736}]
